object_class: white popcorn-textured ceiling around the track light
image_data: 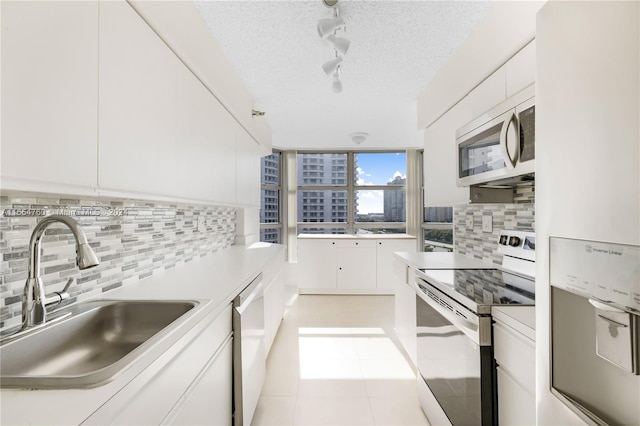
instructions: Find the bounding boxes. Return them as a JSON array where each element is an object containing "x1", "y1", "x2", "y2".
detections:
[{"x1": 194, "y1": 0, "x2": 495, "y2": 149}]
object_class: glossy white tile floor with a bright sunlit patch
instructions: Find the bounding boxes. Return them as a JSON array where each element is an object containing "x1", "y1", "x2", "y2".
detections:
[{"x1": 252, "y1": 295, "x2": 429, "y2": 426}]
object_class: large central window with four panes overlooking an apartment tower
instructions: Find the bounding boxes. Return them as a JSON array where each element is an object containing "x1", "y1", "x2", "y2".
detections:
[{"x1": 297, "y1": 152, "x2": 407, "y2": 234}]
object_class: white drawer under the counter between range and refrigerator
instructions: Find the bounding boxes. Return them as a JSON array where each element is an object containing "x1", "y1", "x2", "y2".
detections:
[{"x1": 493, "y1": 322, "x2": 536, "y2": 392}]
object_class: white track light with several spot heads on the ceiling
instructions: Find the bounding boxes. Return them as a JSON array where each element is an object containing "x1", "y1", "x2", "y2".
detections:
[{"x1": 317, "y1": 0, "x2": 351, "y2": 93}]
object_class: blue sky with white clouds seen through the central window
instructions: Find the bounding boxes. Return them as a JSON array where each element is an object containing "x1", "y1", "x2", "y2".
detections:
[{"x1": 356, "y1": 153, "x2": 407, "y2": 214}]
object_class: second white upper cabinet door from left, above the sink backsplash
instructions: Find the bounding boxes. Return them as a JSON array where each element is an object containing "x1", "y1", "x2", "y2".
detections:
[{"x1": 98, "y1": 1, "x2": 179, "y2": 195}]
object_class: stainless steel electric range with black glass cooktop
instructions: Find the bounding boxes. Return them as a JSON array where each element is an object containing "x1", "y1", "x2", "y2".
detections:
[{"x1": 415, "y1": 231, "x2": 535, "y2": 425}]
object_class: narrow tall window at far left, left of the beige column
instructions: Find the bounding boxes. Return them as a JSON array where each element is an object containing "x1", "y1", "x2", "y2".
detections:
[{"x1": 260, "y1": 151, "x2": 282, "y2": 243}]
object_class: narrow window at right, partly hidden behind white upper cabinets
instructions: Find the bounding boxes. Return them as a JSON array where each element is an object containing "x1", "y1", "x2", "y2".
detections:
[{"x1": 421, "y1": 151, "x2": 453, "y2": 252}]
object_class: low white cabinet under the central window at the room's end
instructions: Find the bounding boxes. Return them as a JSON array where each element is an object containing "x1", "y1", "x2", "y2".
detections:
[{"x1": 298, "y1": 237, "x2": 415, "y2": 294}]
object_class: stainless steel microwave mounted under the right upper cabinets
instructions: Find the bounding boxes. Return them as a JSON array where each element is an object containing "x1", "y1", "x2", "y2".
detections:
[{"x1": 456, "y1": 86, "x2": 535, "y2": 186}]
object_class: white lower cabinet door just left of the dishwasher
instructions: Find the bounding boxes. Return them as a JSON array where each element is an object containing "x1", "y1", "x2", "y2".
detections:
[{"x1": 171, "y1": 339, "x2": 233, "y2": 425}]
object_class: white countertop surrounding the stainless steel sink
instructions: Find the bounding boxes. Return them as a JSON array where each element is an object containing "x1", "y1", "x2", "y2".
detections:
[{"x1": 0, "y1": 243, "x2": 284, "y2": 425}]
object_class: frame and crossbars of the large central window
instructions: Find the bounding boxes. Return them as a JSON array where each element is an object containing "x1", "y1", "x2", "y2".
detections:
[{"x1": 295, "y1": 150, "x2": 407, "y2": 234}]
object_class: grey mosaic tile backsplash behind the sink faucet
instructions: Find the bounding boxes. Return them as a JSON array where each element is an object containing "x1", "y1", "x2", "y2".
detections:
[{"x1": 0, "y1": 194, "x2": 236, "y2": 329}]
